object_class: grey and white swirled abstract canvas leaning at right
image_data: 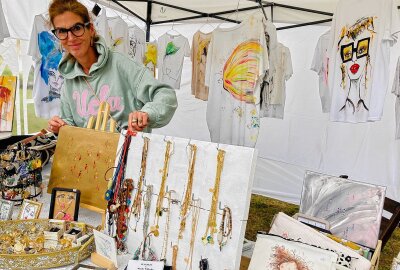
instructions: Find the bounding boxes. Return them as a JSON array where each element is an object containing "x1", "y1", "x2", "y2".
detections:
[{"x1": 300, "y1": 171, "x2": 386, "y2": 248}]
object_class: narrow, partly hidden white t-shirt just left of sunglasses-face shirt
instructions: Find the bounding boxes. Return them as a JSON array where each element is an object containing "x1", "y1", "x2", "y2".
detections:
[{"x1": 311, "y1": 30, "x2": 331, "y2": 113}]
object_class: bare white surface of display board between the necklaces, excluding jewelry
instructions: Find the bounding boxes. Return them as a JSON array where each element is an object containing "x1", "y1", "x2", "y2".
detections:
[{"x1": 118, "y1": 133, "x2": 257, "y2": 270}]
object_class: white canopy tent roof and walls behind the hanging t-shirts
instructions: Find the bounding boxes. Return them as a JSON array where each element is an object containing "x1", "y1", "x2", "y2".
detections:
[{"x1": 1, "y1": 0, "x2": 400, "y2": 205}]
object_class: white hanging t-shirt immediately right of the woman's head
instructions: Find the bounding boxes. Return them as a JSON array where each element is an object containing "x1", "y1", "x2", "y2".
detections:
[{"x1": 106, "y1": 16, "x2": 129, "y2": 55}]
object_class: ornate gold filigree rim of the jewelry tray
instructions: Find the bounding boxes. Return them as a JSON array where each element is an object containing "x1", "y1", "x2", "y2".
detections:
[{"x1": 0, "y1": 219, "x2": 95, "y2": 269}]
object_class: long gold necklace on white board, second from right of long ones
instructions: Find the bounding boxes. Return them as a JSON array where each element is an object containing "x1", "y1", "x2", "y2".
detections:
[{"x1": 178, "y1": 144, "x2": 197, "y2": 239}]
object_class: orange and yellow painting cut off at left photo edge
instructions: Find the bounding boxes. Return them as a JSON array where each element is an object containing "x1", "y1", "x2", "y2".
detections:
[{"x1": 0, "y1": 76, "x2": 17, "y2": 132}]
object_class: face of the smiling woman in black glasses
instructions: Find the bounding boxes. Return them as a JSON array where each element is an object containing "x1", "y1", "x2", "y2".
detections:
[{"x1": 53, "y1": 11, "x2": 94, "y2": 62}]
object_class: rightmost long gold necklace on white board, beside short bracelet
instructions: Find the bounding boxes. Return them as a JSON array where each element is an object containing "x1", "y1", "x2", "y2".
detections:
[{"x1": 201, "y1": 149, "x2": 225, "y2": 244}]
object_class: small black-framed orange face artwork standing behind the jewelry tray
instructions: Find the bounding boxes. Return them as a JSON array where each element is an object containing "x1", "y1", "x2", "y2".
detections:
[{"x1": 49, "y1": 188, "x2": 81, "y2": 221}]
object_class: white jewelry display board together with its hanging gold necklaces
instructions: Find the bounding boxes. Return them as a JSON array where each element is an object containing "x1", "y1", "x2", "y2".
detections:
[{"x1": 108, "y1": 133, "x2": 257, "y2": 270}]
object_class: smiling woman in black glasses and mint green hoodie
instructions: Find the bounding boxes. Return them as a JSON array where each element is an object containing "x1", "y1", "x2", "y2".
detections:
[{"x1": 49, "y1": 0, "x2": 177, "y2": 133}]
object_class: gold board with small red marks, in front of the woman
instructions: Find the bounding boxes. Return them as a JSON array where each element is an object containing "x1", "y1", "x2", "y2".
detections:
[{"x1": 47, "y1": 126, "x2": 119, "y2": 209}]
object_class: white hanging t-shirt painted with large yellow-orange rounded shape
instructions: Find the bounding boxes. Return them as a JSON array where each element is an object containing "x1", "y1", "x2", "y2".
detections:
[{"x1": 205, "y1": 16, "x2": 268, "y2": 147}]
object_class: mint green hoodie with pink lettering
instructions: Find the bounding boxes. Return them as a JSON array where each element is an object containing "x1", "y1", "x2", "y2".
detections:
[{"x1": 58, "y1": 37, "x2": 178, "y2": 132}]
